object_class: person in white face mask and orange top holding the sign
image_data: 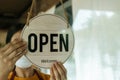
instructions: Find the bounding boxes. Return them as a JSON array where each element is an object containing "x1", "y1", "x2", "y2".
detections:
[{"x1": 0, "y1": 0, "x2": 67, "y2": 80}]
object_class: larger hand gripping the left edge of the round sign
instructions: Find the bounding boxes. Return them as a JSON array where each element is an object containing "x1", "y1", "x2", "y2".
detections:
[{"x1": 0, "y1": 39, "x2": 27, "y2": 80}]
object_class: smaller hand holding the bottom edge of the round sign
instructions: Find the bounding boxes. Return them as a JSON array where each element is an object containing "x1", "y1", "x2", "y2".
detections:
[{"x1": 50, "y1": 62, "x2": 67, "y2": 80}]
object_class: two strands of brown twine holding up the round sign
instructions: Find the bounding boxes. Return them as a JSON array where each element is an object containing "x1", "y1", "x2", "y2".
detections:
[{"x1": 26, "y1": 0, "x2": 69, "y2": 28}]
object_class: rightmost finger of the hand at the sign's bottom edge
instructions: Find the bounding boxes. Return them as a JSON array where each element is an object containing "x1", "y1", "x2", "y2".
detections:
[{"x1": 55, "y1": 62, "x2": 67, "y2": 80}]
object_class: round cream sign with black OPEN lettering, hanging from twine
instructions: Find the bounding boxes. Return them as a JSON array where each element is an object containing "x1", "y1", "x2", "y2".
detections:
[{"x1": 22, "y1": 14, "x2": 74, "y2": 68}]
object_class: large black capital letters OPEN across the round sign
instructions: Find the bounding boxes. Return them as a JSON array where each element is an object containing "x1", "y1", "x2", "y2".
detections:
[{"x1": 28, "y1": 31, "x2": 69, "y2": 53}]
